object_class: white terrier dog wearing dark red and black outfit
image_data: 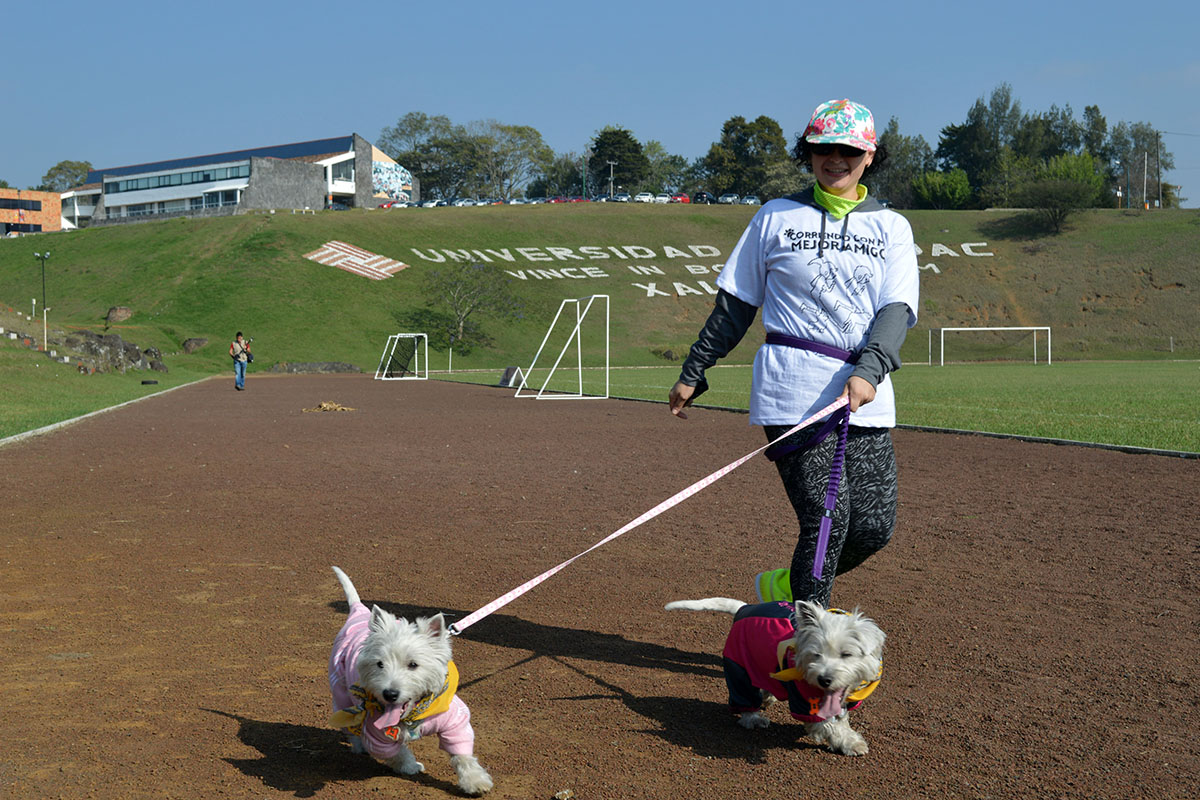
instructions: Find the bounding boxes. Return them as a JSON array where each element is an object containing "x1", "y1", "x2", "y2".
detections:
[{"x1": 666, "y1": 597, "x2": 884, "y2": 756}]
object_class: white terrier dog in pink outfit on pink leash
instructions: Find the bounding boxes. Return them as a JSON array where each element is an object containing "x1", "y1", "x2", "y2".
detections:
[{"x1": 329, "y1": 566, "x2": 492, "y2": 794}]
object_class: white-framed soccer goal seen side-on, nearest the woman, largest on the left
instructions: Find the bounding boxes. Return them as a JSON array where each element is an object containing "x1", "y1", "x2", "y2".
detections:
[{"x1": 515, "y1": 294, "x2": 610, "y2": 399}]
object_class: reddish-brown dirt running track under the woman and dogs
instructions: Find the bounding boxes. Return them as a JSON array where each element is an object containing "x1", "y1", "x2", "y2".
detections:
[{"x1": 0, "y1": 374, "x2": 1200, "y2": 800}]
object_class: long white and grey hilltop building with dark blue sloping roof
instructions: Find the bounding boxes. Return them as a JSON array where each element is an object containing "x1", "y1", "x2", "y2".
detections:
[{"x1": 62, "y1": 133, "x2": 420, "y2": 228}]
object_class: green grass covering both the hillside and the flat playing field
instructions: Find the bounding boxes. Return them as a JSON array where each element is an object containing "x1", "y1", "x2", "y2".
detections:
[{"x1": 0, "y1": 204, "x2": 1200, "y2": 452}]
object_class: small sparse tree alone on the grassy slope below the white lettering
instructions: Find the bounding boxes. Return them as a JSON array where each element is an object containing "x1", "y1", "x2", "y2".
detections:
[{"x1": 425, "y1": 261, "x2": 520, "y2": 348}]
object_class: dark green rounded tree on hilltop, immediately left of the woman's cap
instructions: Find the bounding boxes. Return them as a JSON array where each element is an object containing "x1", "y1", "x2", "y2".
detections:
[{"x1": 704, "y1": 115, "x2": 791, "y2": 196}]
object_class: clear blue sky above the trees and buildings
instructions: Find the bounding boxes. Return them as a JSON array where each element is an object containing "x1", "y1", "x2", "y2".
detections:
[{"x1": 0, "y1": 0, "x2": 1200, "y2": 207}]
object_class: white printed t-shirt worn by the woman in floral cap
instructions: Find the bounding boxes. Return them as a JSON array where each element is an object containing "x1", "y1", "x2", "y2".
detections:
[{"x1": 716, "y1": 198, "x2": 920, "y2": 427}]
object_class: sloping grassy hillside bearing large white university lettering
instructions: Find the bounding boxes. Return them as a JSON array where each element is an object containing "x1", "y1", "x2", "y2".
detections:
[{"x1": 0, "y1": 204, "x2": 1200, "y2": 381}]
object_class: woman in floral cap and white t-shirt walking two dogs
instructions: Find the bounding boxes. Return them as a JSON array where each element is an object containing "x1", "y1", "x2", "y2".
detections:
[{"x1": 670, "y1": 100, "x2": 919, "y2": 606}]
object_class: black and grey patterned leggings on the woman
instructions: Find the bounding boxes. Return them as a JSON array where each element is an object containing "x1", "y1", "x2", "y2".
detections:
[{"x1": 764, "y1": 425, "x2": 898, "y2": 607}]
